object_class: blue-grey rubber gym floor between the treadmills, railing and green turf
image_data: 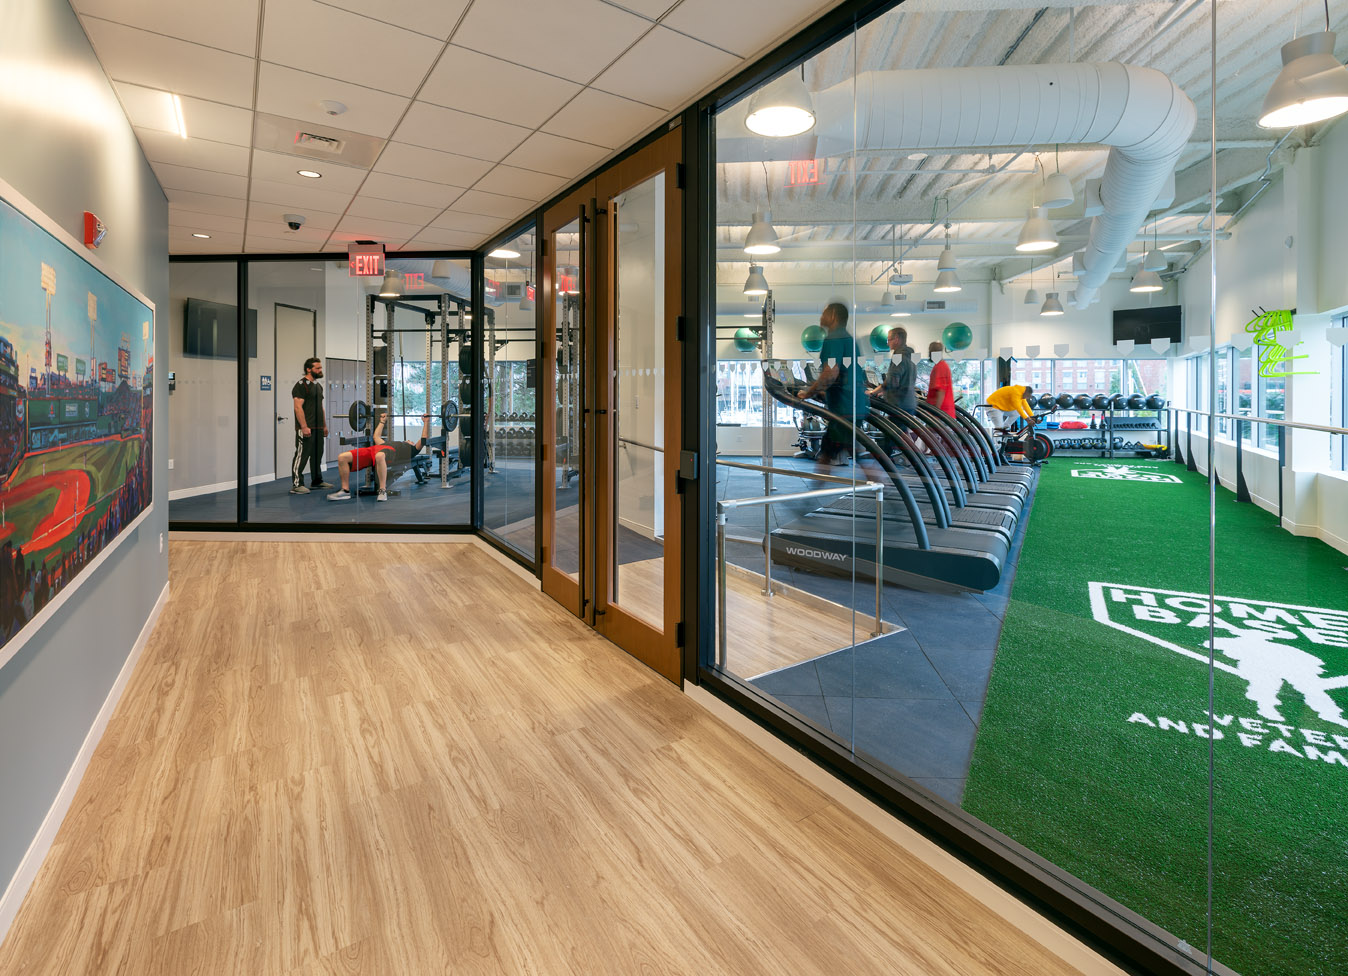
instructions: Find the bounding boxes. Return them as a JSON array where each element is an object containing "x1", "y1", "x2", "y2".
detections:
[{"x1": 717, "y1": 457, "x2": 1034, "y2": 803}]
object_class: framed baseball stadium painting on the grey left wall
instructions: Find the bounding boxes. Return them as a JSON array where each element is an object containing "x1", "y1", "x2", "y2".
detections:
[{"x1": 0, "y1": 187, "x2": 154, "y2": 663}]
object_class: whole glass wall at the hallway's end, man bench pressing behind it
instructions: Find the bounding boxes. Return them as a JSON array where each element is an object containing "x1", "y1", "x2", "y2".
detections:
[{"x1": 170, "y1": 256, "x2": 472, "y2": 526}]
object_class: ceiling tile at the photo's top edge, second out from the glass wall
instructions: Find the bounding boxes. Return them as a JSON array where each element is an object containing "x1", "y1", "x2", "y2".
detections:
[{"x1": 454, "y1": 0, "x2": 651, "y2": 82}]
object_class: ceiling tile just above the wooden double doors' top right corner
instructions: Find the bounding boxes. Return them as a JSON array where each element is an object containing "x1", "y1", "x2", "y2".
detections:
[{"x1": 594, "y1": 27, "x2": 741, "y2": 109}]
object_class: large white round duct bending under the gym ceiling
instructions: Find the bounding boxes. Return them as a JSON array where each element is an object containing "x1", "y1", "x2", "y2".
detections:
[{"x1": 798, "y1": 62, "x2": 1197, "y2": 309}]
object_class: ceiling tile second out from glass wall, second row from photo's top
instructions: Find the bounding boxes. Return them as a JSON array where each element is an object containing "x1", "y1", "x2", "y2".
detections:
[{"x1": 417, "y1": 44, "x2": 581, "y2": 128}]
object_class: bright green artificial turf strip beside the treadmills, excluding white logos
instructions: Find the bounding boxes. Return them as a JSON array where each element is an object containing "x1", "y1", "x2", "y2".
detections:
[{"x1": 964, "y1": 458, "x2": 1348, "y2": 976}]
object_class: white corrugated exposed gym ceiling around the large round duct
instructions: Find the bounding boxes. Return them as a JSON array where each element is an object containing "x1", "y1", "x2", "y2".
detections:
[{"x1": 717, "y1": 0, "x2": 1348, "y2": 301}]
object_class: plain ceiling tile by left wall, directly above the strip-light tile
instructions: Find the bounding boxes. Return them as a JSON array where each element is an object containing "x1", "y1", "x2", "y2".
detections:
[{"x1": 84, "y1": 18, "x2": 253, "y2": 106}]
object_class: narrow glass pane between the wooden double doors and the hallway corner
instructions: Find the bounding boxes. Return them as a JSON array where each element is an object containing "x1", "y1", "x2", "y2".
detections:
[{"x1": 483, "y1": 229, "x2": 539, "y2": 561}]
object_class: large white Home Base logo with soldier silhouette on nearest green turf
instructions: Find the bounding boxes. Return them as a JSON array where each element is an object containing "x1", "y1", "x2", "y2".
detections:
[{"x1": 1088, "y1": 582, "x2": 1348, "y2": 768}]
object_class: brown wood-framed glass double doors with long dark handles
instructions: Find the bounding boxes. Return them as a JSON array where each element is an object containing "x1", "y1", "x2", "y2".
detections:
[{"x1": 541, "y1": 132, "x2": 682, "y2": 681}]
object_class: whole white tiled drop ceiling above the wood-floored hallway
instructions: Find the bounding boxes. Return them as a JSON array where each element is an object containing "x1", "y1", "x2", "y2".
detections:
[{"x1": 71, "y1": 0, "x2": 837, "y2": 253}]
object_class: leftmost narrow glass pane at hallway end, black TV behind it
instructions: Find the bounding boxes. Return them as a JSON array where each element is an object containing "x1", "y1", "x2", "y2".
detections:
[{"x1": 164, "y1": 262, "x2": 241, "y2": 523}]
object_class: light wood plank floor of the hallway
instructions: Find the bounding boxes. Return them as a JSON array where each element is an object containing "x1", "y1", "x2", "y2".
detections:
[{"x1": 0, "y1": 542, "x2": 1116, "y2": 976}]
